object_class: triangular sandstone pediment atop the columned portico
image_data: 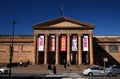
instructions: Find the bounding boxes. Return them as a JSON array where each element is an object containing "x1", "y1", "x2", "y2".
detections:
[{"x1": 33, "y1": 17, "x2": 94, "y2": 29}]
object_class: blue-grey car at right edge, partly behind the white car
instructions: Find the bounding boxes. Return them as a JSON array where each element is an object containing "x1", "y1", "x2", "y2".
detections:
[{"x1": 106, "y1": 65, "x2": 120, "y2": 75}]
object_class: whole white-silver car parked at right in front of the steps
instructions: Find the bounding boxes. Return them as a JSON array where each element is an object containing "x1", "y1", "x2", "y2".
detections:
[{"x1": 83, "y1": 66, "x2": 115, "y2": 76}]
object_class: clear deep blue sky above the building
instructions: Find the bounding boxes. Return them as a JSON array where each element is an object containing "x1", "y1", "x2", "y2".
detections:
[{"x1": 0, "y1": 0, "x2": 120, "y2": 35}]
